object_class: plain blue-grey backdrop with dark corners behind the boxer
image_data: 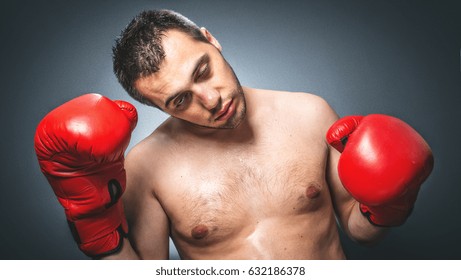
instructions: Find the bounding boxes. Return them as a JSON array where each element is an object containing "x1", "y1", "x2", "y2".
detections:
[{"x1": 0, "y1": 0, "x2": 461, "y2": 259}]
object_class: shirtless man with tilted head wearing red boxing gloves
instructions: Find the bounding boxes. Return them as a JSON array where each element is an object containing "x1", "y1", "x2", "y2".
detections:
[{"x1": 35, "y1": 11, "x2": 432, "y2": 259}]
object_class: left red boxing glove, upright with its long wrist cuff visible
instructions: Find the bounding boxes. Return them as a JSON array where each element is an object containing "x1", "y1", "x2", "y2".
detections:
[{"x1": 34, "y1": 94, "x2": 137, "y2": 257}]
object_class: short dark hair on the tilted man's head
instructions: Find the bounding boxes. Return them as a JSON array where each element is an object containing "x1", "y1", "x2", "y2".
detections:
[{"x1": 112, "y1": 10, "x2": 208, "y2": 107}]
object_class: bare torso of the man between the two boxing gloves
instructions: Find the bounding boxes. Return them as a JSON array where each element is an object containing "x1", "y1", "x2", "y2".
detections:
[{"x1": 131, "y1": 90, "x2": 344, "y2": 259}]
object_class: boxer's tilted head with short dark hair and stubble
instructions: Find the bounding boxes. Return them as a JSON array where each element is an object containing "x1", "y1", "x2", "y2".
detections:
[{"x1": 113, "y1": 10, "x2": 245, "y2": 128}]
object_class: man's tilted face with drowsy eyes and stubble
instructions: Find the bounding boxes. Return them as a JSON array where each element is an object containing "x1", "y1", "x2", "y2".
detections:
[{"x1": 135, "y1": 30, "x2": 245, "y2": 128}]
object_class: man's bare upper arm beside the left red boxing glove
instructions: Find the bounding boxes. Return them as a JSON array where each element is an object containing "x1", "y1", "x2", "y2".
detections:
[{"x1": 123, "y1": 143, "x2": 169, "y2": 259}]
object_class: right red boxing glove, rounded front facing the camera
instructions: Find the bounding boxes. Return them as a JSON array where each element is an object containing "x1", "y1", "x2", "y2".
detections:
[{"x1": 326, "y1": 114, "x2": 434, "y2": 226}]
